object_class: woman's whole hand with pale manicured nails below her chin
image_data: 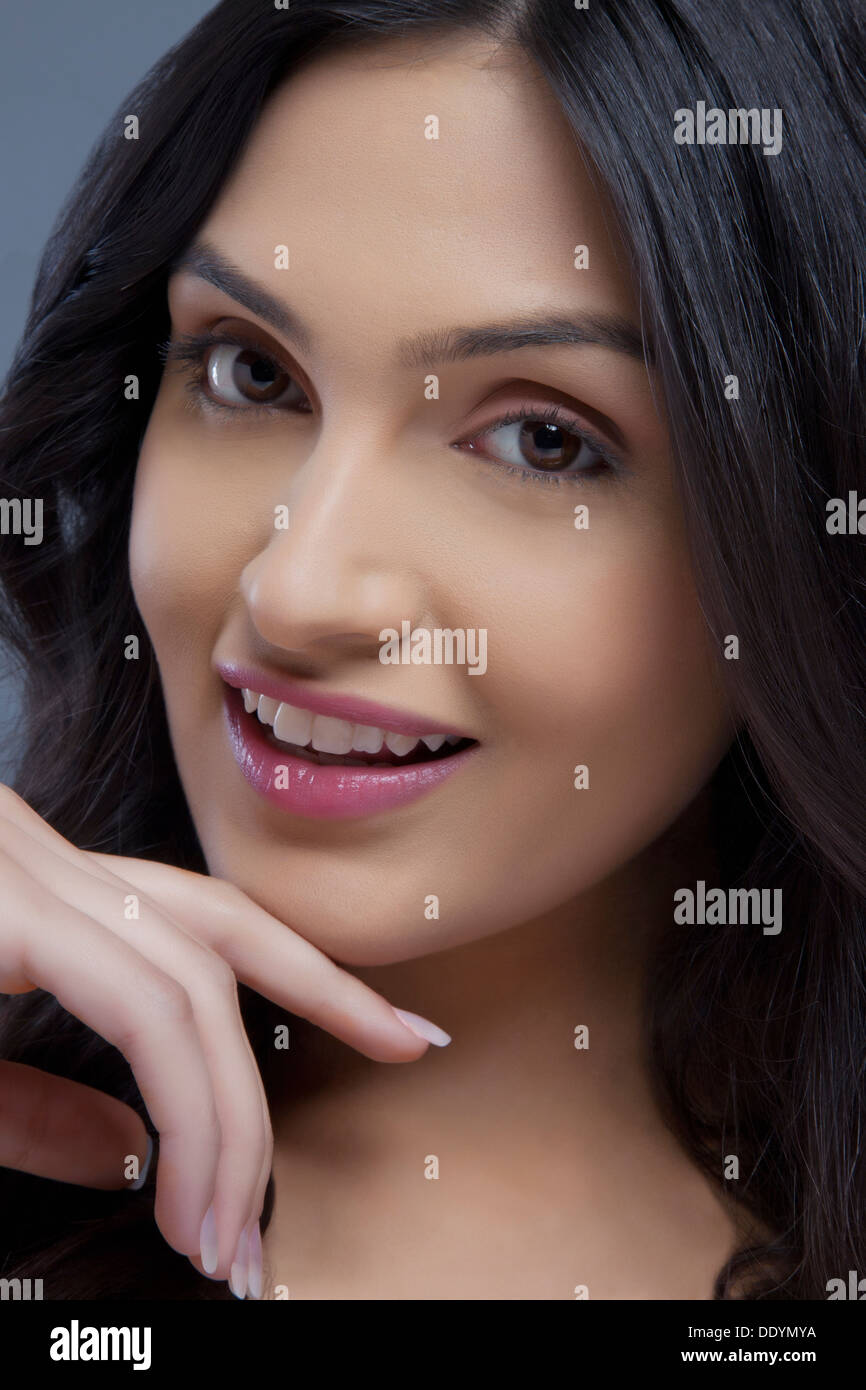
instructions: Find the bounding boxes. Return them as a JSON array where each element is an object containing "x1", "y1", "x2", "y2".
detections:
[{"x1": 0, "y1": 784, "x2": 428, "y2": 1295}]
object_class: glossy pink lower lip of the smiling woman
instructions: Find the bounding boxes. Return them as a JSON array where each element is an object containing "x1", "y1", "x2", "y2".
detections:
[{"x1": 225, "y1": 687, "x2": 478, "y2": 820}]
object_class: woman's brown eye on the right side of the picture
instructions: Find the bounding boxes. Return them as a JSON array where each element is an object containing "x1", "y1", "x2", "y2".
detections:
[{"x1": 463, "y1": 406, "x2": 613, "y2": 482}]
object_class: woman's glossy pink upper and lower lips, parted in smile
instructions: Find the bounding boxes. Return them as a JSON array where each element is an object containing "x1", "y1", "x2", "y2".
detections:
[{"x1": 217, "y1": 664, "x2": 480, "y2": 820}]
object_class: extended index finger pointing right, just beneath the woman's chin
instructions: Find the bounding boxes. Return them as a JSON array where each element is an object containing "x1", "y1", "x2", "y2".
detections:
[{"x1": 88, "y1": 853, "x2": 439, "y2": 1062}]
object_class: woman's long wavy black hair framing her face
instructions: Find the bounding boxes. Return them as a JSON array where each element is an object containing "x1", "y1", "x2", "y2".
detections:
[{"x1": 0, "y1": 0, "x2": 866, "y2": 1298}]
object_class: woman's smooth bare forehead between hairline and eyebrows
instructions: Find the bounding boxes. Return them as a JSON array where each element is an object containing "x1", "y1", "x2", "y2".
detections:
[{"x1": 189, "y1": 36, "x2": 635, "y2": 353}]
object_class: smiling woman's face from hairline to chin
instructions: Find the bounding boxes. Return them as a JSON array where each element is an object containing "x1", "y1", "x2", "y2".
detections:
[{"x1": 131, "y1": 38, "x2": 731, "y2": 966}]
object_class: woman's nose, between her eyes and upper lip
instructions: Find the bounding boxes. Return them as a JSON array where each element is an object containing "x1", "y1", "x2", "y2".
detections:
[{"x1": 240, "y1": 427, "x2": 427, "y2": 649}]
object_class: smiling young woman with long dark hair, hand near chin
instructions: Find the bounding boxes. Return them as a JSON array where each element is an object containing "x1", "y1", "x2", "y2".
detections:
[{"x1": 0, "y1": 0, "x2": 866, "y2": 1300}]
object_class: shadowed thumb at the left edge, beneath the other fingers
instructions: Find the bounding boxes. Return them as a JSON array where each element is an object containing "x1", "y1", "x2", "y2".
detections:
[{"x1": 0, "y1": 1062, "x2": 149, "y2": 1190}]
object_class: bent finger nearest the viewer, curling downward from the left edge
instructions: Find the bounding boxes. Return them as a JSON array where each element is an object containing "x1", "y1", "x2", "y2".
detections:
[{"x1": 0, "y1": 851, "x2": 221, "y2": 1255}]
